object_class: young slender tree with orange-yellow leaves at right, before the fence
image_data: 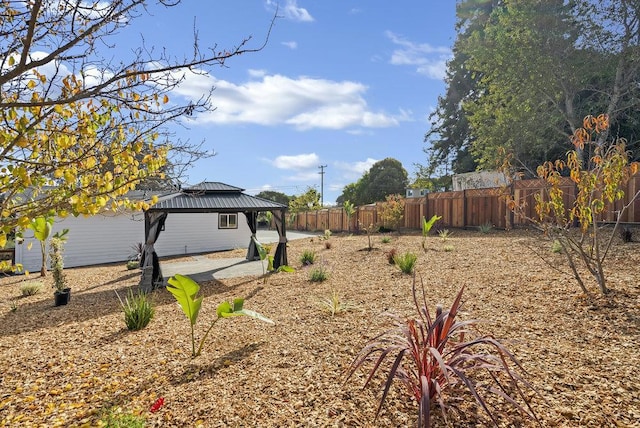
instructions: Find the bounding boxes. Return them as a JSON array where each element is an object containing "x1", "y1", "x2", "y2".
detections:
[{"x1": 508, "y1": 114, "x2": 640, "y2": 295}]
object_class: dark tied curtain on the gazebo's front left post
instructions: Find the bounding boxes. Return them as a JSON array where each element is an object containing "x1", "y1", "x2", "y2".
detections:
[{"x1": 140, "y1": 211, "x2": 167, "y2": 293}]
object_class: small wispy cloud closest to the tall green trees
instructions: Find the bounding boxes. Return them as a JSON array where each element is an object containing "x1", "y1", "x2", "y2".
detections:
[{"x1": 385, "y1": 31, "x2": 452, "y2": 79}]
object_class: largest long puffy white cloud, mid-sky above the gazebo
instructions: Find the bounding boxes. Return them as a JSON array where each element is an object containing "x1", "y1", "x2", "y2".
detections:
[{"x1": 169, "y1": 70, "x2": 410, "y2": 130}]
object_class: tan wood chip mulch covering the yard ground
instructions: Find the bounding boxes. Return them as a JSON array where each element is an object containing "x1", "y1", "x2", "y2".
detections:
[{"x1": 0, "y1": 230, "x2": 640, "y2": 427}]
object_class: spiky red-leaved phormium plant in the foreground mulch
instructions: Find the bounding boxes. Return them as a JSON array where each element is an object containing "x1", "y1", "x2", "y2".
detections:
[{"x1": 347, "y1": 276, "x2": 537, "y2": 427}]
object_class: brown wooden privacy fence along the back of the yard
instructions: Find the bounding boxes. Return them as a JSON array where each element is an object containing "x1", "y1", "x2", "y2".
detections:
[{"x1": 287, "y1": 174, "x2": 640, "y2": 232}]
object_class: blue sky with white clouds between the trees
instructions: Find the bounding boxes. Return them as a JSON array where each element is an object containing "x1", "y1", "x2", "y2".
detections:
[{"x1": 121, "y1": 0, "x2": 455, "y2": 204}]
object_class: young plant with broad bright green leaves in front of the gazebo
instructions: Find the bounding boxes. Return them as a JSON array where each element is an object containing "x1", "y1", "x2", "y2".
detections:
[{"x1": 167, "y1": 274, "x2": 274, "y2": 358}]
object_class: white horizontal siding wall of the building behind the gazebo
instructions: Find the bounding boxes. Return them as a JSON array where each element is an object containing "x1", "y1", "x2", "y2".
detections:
[{"x1": 16, "y1": 213, "x2": 251, "y2": 272}]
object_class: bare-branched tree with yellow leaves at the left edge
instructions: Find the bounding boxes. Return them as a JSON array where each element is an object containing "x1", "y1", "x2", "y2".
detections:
[{"x1": 0, "y1": 0, "x2": 268, "y2": 268}]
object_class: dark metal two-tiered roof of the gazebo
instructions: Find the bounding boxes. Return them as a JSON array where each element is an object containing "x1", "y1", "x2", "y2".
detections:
[{"x1": 149, "y1": 182, "x2": 287, "y2": 213}]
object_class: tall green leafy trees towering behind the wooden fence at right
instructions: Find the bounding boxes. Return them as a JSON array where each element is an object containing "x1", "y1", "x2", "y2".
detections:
[{"x1": 422, "y1": 0, "x2": 640, "y2": 177}]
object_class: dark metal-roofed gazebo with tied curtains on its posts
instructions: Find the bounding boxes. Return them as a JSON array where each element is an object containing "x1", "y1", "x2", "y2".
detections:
[{"x1": 140, "y1": 182, "x2": 287, "y2": 292}]
